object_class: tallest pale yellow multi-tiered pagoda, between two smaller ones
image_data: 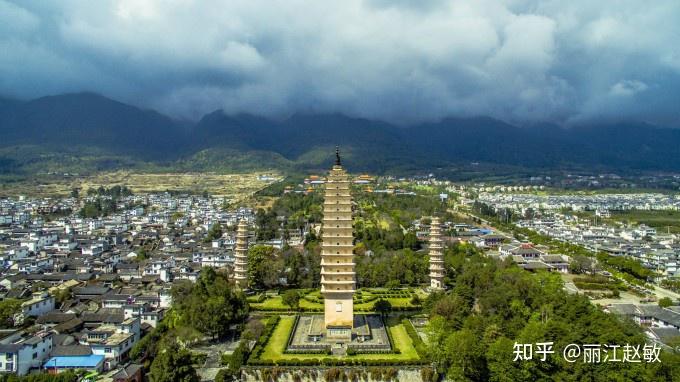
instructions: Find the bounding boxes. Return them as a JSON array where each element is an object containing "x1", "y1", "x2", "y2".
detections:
[{"x1": 321, "y1": 148, "x2": 355, "y2": 340}]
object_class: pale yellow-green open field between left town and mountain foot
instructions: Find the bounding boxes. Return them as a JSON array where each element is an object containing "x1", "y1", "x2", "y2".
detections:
[{"x1": 0, "y1": 171, "x2": 281, "y2": 201}]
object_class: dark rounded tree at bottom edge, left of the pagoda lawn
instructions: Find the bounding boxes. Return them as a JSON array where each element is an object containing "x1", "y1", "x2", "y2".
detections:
[{"x1": 149, "y1": 344, "x2": 200, "y2": 382}]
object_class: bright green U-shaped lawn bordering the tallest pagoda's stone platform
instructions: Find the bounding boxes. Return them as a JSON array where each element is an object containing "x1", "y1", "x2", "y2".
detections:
[{"x1": 260, "y1": 316, "x2": 420, "y2": 361}]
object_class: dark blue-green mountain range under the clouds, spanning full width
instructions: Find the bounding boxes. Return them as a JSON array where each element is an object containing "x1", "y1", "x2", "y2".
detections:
[{"x1": 0, "y1": 93, "x2": 680, "y2": 174}]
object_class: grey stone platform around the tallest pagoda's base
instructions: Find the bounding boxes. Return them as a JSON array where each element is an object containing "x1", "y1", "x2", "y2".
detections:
[{"x1": 286, "y1": 314, "x2": 392, "y2": 354}]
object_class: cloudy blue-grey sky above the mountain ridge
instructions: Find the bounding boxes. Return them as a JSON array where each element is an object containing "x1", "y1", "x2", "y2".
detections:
[{"x1": 0, "y1": 0, "x2": 680, "y2": 126}]
